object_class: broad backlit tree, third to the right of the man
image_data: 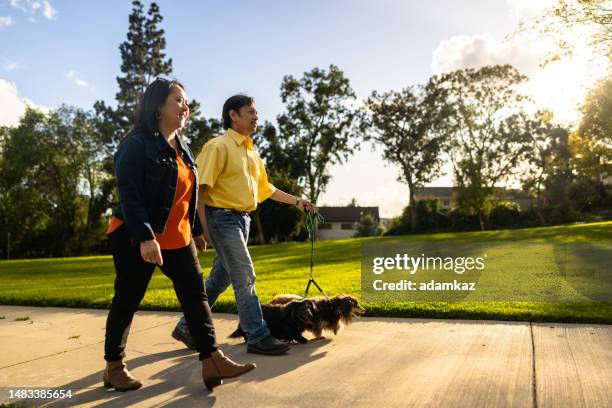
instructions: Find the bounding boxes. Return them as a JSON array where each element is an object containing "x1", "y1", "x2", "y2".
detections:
[{"x1": 439, "y1": 65, "x2": 533, "y2": 229}]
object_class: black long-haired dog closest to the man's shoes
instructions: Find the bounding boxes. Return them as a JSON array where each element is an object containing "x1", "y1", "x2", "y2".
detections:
[{"x1": 229, "y1": 299, "x2": 315, "y2": 343}]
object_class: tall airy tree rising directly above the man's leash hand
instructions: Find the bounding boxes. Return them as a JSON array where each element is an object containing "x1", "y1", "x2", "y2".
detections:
[{"x1": 277, "y1": 65, "x2": 355, "y2": 203}]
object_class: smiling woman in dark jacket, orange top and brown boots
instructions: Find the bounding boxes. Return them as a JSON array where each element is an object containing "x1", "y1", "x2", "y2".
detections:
[{"x1": 104, "y1": 79, "x2": 255, "y2": 391}]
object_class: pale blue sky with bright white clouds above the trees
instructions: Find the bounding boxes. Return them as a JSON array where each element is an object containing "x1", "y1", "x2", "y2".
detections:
[{"x1": 0, "y1": 0, "x2": 599, "y2": 217}]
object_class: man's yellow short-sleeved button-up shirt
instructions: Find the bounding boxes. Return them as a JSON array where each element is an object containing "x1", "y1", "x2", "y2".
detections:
[{"x1": 196, "y1": 129, "x2": 276, "y2": 211}]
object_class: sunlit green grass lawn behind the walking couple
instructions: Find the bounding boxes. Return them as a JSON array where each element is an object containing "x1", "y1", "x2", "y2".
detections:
[{"x1": 0, "y1": 222, "x2": 612, "y2": 323}]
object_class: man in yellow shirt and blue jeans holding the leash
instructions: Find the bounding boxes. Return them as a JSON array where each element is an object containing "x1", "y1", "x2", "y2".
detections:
[{"x1": 172, "y1": 95, "x2": 314, "y2": 355}]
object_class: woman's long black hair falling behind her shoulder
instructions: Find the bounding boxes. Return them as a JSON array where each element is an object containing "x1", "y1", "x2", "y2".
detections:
[{"x1": 126, "y1": 78, "x2": 185, "y2": 137}]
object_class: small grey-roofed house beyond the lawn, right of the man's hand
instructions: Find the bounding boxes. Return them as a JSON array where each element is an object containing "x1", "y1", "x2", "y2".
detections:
[{"x1": 317, "y1": 207, "x2": 380, "y2": 240}]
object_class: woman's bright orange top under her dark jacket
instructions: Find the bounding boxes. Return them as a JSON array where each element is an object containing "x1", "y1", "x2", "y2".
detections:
[{"x1": 106, "y1": 147, "x2": 195, "y2": 249}]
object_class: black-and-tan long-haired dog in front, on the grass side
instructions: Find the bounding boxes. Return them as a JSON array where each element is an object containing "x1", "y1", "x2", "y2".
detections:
[{"x1": 270, "y1": 294, "x2": 365, "y2": 337}]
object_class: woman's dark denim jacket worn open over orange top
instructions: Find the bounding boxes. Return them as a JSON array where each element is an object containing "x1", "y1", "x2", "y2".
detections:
[{"x1": 113, "y1": 133, "x2": 202, "y2": 244}]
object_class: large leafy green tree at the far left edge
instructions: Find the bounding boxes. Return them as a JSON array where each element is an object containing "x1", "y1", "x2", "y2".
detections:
[{"x1": 0, "y1": 106, "x2": 104, "y2": 256}]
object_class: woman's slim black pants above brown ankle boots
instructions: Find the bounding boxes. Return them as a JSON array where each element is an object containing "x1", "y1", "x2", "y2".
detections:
[{"x1": 104, "y1": 225, "x2": 217, "y2": 361}]
